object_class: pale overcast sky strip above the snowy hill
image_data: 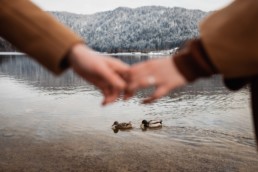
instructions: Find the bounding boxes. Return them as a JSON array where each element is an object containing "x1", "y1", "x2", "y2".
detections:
[{"x1": 32, "y1": 0, "x2": 232, "y2": 14}]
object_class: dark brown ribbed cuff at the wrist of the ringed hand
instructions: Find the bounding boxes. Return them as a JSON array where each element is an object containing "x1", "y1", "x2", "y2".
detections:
[{"x1": 172, "y1": 39, "x2": 218, "y2": 82}]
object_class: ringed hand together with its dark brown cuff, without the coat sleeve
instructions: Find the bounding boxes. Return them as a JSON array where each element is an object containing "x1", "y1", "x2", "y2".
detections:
[{"x1": 125, "y1": 39, "x2": 217, "y2": 103}]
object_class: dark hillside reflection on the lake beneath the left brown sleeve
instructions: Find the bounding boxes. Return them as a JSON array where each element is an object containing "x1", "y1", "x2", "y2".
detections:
[{"x1": 0, "y1": 56, "x2": 85, "y2": 91}]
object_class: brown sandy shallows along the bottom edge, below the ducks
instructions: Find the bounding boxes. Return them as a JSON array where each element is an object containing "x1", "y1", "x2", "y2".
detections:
[{"x1": 0, "y1": 130, "x2": 258, "y2": 171}]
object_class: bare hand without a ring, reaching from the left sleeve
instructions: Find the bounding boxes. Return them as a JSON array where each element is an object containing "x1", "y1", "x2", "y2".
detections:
[{"x1": 68, "y1": 44, "x2": 129, "y2": 105}]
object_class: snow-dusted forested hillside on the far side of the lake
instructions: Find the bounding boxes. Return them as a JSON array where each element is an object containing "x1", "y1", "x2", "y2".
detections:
[{"x1": 0, "y1": 6, "x2": 207, "y2": 53}]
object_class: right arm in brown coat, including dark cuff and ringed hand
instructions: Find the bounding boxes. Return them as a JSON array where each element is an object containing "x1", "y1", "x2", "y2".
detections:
[{"x1": 127, "y1": 0, "x2": 258, "y2": 103}]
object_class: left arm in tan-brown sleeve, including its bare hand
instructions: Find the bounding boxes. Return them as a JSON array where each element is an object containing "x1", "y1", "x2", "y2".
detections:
[{"x1": 0, "y1": 0, "x2": 128, "y2": 104}]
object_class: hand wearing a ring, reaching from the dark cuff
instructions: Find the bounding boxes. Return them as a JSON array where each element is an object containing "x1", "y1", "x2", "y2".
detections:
[{"x1": 124, "y1": 58, "x2": 187, "y2": 103}]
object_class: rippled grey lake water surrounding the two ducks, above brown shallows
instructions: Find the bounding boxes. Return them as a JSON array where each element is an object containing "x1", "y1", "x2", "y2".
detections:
[{"x1": 0, "y1": 56, "x2": 257, "y2": 171}]
